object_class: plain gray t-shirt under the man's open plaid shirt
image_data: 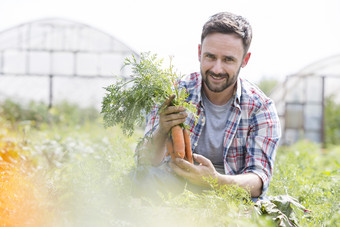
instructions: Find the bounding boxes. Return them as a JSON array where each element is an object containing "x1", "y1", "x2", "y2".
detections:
[{"x1": 194, "y1": 92, "x2": 232, "y2": 174}]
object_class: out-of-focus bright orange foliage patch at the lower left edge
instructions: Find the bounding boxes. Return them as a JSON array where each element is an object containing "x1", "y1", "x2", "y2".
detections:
[{"x1": 0, "y1": 124, "x2": 49, "y2": 226}]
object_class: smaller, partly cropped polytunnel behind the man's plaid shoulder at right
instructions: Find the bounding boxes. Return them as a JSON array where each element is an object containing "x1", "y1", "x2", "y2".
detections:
[{"x1": 270, "y1": 55, "x2": 340, "y2": 144}]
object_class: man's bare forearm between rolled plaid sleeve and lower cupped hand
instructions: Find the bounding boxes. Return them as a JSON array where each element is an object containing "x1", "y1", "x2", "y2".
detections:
[{"x1": 217, "y1": 173, "x2": 263, "y2": 197}]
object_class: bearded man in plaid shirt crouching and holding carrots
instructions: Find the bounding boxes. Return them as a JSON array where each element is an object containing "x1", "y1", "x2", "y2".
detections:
[{"x1": 135, "y1": 12, "x2": 281, "y2": 198}]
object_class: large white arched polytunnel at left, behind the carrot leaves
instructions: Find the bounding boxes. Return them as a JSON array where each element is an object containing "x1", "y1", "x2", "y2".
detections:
[{"x1": 0, "y1": 19, "x2": 138, "y2": 108}]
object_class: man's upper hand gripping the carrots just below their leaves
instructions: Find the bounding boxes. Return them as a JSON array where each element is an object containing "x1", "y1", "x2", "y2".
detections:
[{"x1": 159, "y1": 95, "x2": 188, "y2": 134}]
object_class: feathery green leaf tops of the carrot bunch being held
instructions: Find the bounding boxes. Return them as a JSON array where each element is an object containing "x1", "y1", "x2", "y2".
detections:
[{"x1": 101, "y1": 53, "x2": 195, "y2": 135}]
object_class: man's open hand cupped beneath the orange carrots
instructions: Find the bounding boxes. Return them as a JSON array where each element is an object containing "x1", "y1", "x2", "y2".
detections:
[{"x1": 170, "y1": 154, "x2": 218, "y2": 186}]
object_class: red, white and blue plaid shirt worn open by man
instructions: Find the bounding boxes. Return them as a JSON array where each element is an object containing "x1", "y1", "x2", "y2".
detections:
[{"x1": 145, "y1": 73, "x2": 281, "y2": 195}]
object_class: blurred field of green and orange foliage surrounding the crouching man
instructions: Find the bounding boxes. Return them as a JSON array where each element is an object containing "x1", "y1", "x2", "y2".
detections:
[{"x1": 0, "y1": 100, "x2": 340, "y2": 227}]
